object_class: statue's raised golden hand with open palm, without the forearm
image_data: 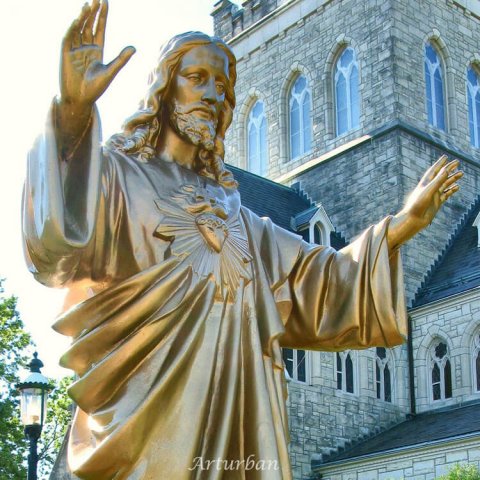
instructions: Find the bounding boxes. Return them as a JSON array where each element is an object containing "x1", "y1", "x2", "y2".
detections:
[{"x1": 60, "y1": 0, "x2": 135, "y2": 108}]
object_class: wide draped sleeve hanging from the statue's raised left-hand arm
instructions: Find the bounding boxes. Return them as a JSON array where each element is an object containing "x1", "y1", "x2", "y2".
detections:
[{"x1": 22, "y1": 102, "x2": 104, "y2": 287}]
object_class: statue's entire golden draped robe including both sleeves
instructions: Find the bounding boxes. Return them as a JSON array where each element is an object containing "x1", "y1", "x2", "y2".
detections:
[{"x1": 23, "y1": 109, "x2": 406, "y2": 480}]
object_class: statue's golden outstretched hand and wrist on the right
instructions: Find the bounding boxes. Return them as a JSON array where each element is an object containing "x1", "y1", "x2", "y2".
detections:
[{"x1": 387, "y1": 155, "x2": 463, "y2": 251}]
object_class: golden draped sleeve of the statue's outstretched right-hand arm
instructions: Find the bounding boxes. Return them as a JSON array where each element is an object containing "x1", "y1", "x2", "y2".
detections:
[{"x1": 277, "y1": 218, "x2": 407, "y2": 350}]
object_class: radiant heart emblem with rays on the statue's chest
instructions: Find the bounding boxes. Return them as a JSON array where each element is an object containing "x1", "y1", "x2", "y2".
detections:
[{"x1": 153, "y1": 182, "x2": 252, "y2": 298}]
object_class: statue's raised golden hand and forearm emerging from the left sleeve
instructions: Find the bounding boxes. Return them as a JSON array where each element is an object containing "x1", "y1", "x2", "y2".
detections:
[{"x1": 55, "y1": 0, "x2": 135, "y2": 158}]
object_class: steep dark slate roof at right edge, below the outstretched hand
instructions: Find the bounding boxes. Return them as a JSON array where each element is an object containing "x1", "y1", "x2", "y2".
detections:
[{"x1": 413, "y1": 199, "x2": 480, "y2": 307}]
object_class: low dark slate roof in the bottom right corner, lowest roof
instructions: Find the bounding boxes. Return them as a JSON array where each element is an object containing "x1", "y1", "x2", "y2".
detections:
[{"x1": 312, "y1": 403, "x2": 480, "y2": 468}]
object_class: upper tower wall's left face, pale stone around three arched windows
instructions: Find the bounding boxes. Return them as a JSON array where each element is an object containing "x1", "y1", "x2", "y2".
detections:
[{"x1": 226, "y1": 0, "x2": 402, "y2": 178}]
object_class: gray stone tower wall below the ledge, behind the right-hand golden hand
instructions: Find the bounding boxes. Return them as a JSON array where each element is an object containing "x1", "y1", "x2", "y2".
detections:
[{"x1": 294, "y1": 130, "x2": 480, "y2": 305}]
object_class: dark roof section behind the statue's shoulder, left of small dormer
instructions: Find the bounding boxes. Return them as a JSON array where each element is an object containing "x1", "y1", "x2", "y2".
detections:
[{"x1": 228, "y1": 165, "x2": 312, "y2": 230}]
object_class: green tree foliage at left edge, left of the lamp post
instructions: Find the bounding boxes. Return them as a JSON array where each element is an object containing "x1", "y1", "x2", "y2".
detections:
[{"x1": 0, "y1": 280, "x2": 32, "y2": 480}]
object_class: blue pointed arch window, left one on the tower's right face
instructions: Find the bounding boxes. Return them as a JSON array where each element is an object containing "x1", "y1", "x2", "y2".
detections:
[{"x1": 425, "y1": 43, "x2": 445, "y2": 130}]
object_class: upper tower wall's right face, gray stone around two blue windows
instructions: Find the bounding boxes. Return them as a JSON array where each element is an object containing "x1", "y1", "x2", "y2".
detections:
[{"x1": 391, "y1": 0, "x2": 480, "y2": 160}]
